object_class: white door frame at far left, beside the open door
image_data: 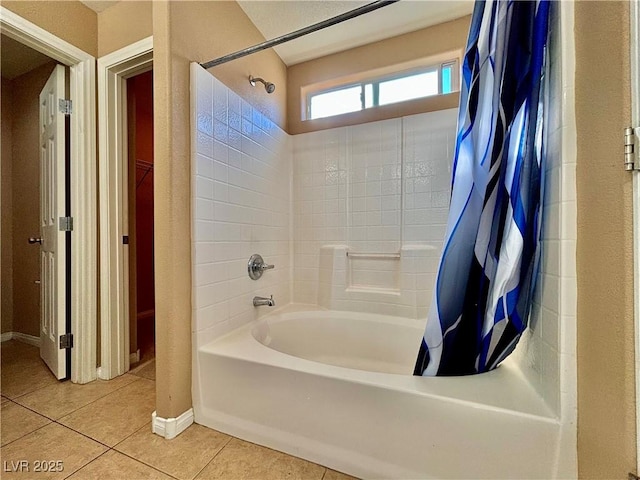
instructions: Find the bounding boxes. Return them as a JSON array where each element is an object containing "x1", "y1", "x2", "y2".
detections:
[{"x1": 0, "y1": 6, "x2": 98, "y2": 383}]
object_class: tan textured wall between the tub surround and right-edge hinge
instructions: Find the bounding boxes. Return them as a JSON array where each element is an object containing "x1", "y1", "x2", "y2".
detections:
[{"x1": 575, "y1": 1, "x2": 638, "y2": 478}]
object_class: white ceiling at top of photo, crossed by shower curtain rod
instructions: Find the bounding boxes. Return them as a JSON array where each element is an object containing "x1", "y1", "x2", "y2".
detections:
[{"x1": 77, "y1": 0, "x2": 473, "y2": 65}]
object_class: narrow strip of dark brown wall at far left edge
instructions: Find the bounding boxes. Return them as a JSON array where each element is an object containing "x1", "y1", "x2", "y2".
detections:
[{"x1": 0, "y1": 78, "x2": 13, "y2": 333}]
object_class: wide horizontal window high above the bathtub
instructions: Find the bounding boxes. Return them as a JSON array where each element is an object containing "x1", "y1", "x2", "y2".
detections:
[{"x1": 306, "y1": 60, "x2": 459, "y2": 120}]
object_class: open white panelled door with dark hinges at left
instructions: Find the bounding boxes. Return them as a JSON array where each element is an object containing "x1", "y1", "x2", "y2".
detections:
[{"x1": 40, "y1": 65, "x2": 67, "y2": 379}]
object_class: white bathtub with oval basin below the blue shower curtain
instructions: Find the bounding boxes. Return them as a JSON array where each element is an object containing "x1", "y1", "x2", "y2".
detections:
[{"x1": 193, "y1": 306, "x2": 571, "y2": 479}]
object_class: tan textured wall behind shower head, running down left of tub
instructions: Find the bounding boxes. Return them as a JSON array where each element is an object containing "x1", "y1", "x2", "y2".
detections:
[{"x1": 153, "y1": 1, "x2": 287, "y2": 418}]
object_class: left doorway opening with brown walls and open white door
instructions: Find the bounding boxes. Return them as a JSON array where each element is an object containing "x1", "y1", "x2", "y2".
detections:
[{"x1": 0, "y1": 35, "x2": 71, "y2": 380}]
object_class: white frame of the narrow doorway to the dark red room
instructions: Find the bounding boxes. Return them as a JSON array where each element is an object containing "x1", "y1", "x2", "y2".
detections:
[{"x1": 98, "y1": 37, "x2": 153, "y2": 380}]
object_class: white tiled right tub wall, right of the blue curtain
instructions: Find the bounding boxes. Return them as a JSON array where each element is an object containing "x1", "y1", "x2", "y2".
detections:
[{"x1": 515, "y1": 2, "x2": 577, "y2": 450}]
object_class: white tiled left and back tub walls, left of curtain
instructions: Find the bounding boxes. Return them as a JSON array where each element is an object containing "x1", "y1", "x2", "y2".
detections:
[{"x1": 192, "y1": 60, "x2": 457, "y2": 345}]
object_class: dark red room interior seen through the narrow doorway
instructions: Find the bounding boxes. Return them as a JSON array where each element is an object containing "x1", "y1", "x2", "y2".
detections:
[{"x1": 126, "y1": 71, "x2": 155, "y2": 369}]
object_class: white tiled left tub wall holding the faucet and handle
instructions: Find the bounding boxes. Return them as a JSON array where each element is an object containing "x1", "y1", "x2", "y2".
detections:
[{"x1": 191, "y1": 63, "x2": 292, "y2": 346}]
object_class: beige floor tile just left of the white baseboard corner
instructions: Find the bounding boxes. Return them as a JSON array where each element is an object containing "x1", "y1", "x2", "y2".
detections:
[{"x1": 58, "y1": 378, "x2": 156, "y2": 447}]
